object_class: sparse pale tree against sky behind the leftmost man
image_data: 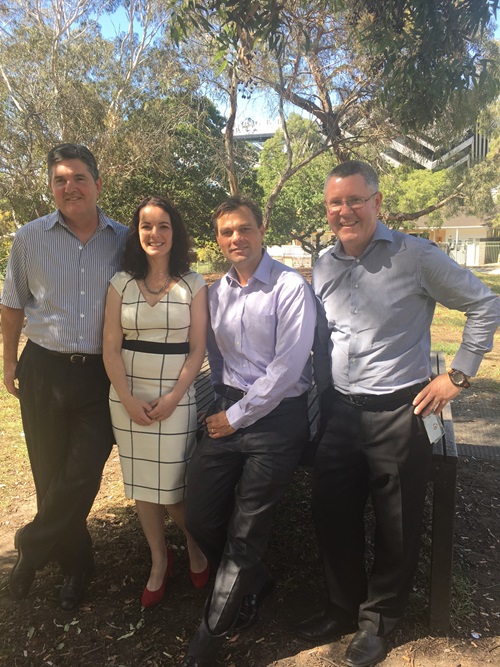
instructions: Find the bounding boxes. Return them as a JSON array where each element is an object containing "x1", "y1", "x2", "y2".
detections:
[{"x1": 0, "y1": 0, "x2": 189, "y2": 222}]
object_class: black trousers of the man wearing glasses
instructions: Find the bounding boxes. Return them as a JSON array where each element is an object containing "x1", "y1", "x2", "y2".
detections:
[{"x1": 313, "y1": 389, "x2": 432, "y2": 636}]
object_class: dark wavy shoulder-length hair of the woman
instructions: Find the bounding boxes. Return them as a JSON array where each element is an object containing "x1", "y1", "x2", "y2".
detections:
[{"x1": 121, "y1": 195, "x2": 191, "y2": 279}]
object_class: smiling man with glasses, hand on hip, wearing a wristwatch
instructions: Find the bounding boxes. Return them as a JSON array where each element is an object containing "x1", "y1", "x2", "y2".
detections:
[{"x1": 297, "y1": 161, "x2": 500, "y2": 667}]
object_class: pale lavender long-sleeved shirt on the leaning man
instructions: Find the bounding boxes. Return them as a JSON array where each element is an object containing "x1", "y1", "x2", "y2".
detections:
[{"x1": 207, "y1": 252, "x2": 316, "y2": 429}]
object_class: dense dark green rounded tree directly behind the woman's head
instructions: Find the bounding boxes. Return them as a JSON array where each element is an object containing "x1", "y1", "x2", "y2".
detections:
[{"x1": 101, "y1": 92, "x2": 235, "y2": 240}]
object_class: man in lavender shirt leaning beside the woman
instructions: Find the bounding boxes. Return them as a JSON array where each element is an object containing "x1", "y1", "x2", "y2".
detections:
[{"x1": 182, "y1": 197, "x2": 316, "y2": 667}]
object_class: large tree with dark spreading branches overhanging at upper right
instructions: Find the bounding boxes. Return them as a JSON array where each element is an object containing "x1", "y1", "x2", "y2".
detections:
[{"x1": 170, "y1": 0, "x2": 499, "y2": 232}]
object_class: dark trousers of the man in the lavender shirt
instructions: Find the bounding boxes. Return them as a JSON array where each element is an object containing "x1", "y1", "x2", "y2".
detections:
[{"x1": 186, "y1": 394, "x2": 309, "y2": 660}]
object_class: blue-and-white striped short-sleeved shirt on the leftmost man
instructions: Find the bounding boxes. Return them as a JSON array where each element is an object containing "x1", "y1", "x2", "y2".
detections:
[{"x1": 2, "y1": 208, "x2": 127, "y2": 354}]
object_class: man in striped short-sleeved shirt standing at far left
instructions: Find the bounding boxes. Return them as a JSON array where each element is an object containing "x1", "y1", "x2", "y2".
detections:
[{"x1": 2, "y1": 144, "x2": 127, "y2": 610}]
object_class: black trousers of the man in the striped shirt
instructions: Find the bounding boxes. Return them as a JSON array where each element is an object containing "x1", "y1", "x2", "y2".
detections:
[{"x1": 17, "y1": 341, "x2": 114, "y2": 574}]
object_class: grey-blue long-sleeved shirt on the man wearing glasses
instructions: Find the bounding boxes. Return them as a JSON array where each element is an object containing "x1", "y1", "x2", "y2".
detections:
[{"x1": 312, "y1": 221, "x2": 500, "y2": 394}]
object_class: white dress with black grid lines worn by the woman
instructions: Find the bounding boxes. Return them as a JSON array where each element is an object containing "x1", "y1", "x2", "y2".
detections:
[{"x1": 109, "y1": 271, "x2": 205, "y2": 505}]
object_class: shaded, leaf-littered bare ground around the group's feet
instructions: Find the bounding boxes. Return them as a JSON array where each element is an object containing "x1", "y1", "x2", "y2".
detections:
[{"x1": 0, "y1": 450, "x2": 500, "y2": 667}]
